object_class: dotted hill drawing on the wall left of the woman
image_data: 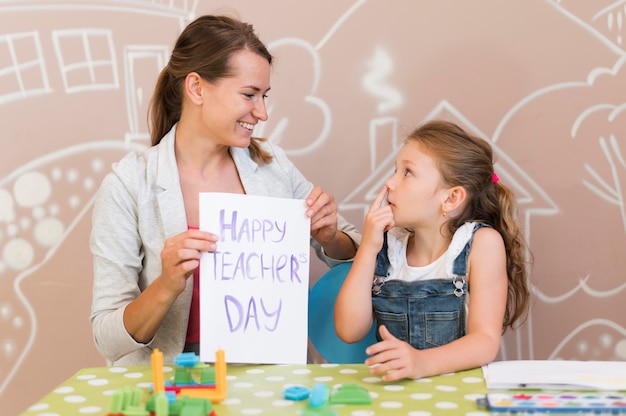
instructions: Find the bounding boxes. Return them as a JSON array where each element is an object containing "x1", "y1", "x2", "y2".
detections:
[{"x1": 0, "y1": 141, "x2": 143, "y2": 392}]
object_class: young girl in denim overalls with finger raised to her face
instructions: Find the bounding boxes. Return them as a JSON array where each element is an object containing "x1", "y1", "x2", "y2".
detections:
[{"x1": 335, "y1": 121, "x2": 529, "y2": 381}]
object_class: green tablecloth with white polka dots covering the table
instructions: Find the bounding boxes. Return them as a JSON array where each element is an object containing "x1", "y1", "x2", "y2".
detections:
[{"x1": 22, "y1": 364, "x2": 489, "y2": 416}]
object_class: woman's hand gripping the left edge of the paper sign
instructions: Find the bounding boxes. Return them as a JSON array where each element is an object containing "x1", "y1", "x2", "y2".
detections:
[{"x1": 160, "y1": 229, "x2": 217, "y2": 296}]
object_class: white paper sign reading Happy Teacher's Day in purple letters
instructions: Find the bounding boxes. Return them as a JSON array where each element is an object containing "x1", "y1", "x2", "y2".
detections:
[{"x1": 199, "y1": 192, "x2": 310, "y2": 364}]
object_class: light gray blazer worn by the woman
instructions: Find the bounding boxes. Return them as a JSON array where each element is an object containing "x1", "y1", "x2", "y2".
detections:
[{"x1": 89, "y1": 126, "x2": 360, "y2": 365}]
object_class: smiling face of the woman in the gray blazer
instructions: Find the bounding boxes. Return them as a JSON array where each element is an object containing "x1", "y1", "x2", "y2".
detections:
[{"x1": 202, "y1": 50, "x2": 270, "y2": 147}]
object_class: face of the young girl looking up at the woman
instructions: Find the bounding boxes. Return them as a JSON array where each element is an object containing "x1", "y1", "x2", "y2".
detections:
[{"x1": 385, "y1": 140, "x2": 447, "y2": 230}]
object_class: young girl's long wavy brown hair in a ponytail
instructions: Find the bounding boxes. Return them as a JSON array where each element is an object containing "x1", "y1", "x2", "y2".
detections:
[{"x1": 407, "y1": 120, "x2": 532, "y2": 331}]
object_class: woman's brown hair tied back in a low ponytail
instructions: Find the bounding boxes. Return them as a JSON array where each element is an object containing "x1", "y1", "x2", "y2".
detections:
[{"x1": 149, "y1": 15, "x2": 272, "y2": 163}]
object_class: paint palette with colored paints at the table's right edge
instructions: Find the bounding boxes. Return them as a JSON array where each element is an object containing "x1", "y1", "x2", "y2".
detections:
[{"x1": 478, "y1": 392, "x2": 626, "y2": 414}]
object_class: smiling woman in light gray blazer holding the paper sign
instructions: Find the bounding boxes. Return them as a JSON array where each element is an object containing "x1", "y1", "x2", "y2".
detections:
[{"x1": 90, "y1": 16, "x2": 359, "y2": 365}]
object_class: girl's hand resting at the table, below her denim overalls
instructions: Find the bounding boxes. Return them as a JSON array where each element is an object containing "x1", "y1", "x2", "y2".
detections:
[{"x1": 365, "y1": 325, "x2": 419, "y2": 381}]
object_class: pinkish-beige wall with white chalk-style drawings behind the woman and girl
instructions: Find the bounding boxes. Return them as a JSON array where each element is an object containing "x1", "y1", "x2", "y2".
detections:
[{"x1": 0, "y1": 0, "x2": 626, "y2": 414}]
